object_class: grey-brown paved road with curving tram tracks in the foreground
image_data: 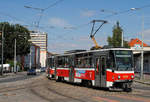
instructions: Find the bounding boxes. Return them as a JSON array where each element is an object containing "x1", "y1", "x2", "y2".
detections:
[{"x1": 0, "y1": 74, "x2": 150, "y2": 102}]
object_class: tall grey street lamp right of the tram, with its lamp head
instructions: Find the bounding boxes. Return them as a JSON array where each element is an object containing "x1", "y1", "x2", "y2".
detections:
[{"x1": 131, "y1": 8, "x2": 144, "y2": 79}]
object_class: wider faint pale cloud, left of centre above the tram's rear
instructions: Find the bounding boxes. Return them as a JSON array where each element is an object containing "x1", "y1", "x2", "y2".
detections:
[{"x1": 49, "y1": 17, "x2": 71, "y2": 28}]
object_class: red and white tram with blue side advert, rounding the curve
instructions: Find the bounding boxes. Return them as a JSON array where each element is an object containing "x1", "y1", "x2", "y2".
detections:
[{"x1": 46, "y1": 48, "x2": 134, "y2": 91}]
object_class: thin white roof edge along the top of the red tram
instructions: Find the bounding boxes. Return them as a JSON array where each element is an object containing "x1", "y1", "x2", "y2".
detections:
[{"x1": 56, "y1": 48, "x2": 132, "y2": 56}]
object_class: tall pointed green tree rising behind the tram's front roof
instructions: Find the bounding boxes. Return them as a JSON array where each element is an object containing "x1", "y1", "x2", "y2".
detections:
[{"x1": 107, "y1": 21, "x2": 129, "y2": 47}]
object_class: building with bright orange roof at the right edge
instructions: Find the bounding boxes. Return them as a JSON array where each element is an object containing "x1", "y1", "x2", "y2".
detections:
[{"x1": 129, "y1": 38, "x2": 150, "y2": 74}]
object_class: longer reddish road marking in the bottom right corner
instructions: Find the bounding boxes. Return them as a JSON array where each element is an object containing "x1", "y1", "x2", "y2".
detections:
[{"x1": 115, "y1": 95, "x2": 150, "y2": 102}]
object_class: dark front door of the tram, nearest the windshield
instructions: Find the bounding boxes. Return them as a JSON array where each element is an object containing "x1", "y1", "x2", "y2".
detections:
[{"x1": 95, "y1": 56, "x2": 106, "y2": 87}]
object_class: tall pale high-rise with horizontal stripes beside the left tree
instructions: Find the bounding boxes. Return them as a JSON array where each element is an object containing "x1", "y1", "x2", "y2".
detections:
[{"x1": 30, "y1": 31, "x2": 47, "y2": 67}]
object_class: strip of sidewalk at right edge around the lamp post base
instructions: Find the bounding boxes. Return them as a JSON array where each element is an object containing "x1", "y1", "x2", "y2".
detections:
[{"x1": 134, "y1": 73, "x2": 150, "y2": 85}]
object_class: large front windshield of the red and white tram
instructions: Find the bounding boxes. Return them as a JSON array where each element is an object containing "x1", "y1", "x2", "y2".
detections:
[{"x1": 115, "y1": 50, "x2": 133, "y2": 70}]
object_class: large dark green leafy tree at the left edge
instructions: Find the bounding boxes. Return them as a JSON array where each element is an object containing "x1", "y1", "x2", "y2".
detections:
[{"x1": 0, "y1": 22, "x2": 30, "y2": 60}]
